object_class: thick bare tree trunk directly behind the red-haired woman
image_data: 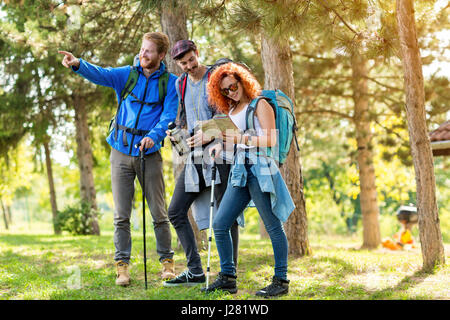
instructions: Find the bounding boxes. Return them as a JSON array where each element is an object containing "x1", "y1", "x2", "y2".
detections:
[{"x1": 261, "y1": 34, "x2": 311, "y2": 256}]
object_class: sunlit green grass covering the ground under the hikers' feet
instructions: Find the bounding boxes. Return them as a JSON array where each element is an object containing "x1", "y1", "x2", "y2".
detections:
[{"x1": 0, "y1": 230, "x2": 450, "y2": 300}]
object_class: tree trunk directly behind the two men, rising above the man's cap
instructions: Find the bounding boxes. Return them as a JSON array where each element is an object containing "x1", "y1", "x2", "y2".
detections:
[{"x1": 160, "y1": 0, "x2": 205, "y2": 250}]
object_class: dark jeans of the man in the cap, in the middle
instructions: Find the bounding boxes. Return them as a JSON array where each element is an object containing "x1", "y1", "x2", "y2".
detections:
[{"x1": 168, "y1": 164, "x2": 239, "y2": 274}]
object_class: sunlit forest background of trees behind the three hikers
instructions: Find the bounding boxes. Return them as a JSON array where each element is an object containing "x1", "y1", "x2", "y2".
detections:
[{"x1": 0, "y1": 0, "x2": 450, "y2": 300}]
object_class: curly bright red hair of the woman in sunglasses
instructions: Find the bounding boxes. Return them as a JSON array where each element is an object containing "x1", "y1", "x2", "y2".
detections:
[{"x1": 208, "y1": 62, "x2": 261, "y2": 114}]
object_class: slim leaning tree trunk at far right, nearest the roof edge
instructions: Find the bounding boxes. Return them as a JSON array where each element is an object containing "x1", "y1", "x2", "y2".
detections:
[{"x1": 396, "y1": 0, "x2": 445, "y2": 271}]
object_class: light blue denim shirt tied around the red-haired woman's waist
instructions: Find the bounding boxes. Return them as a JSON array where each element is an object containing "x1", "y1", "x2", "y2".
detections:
[{"x1": 228, "y1": 148, "x2": 295, "y2": 222}]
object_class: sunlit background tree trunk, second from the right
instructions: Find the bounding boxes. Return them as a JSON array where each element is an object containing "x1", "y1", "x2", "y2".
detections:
[{"x1": 351, "y1": 52, "x2": 381, "y2": 249}]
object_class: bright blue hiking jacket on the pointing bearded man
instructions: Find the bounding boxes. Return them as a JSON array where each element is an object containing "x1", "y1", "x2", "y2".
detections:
[{"x1": 72, "y1": 59, "x2": 178, "y2": 157}]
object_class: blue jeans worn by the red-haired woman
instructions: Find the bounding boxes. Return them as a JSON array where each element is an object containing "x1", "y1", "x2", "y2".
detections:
[{"x1": 213, "y1": 164, "x2": 288, "y2": 280}]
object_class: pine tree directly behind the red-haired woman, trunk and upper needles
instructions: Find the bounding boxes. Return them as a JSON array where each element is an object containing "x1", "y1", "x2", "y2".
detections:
[{"x1": 229, "y1": 1, "x2": 311, "y2": 256}]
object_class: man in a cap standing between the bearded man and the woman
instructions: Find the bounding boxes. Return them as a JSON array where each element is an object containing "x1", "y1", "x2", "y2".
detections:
[{"x1": 164, "y1": 40, "x2": 239, "y2": 287}]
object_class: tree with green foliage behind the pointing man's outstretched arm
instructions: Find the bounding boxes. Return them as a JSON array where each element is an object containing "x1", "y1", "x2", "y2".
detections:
[{"x1": 2, "y1": 1, "x2": 152, "y2": 234}]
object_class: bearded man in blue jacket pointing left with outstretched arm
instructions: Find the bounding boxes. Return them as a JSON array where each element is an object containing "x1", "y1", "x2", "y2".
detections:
[{"x1": 59, "y1": 32, "x2": 178, "y2": 286}]
